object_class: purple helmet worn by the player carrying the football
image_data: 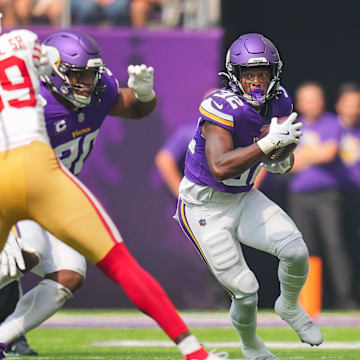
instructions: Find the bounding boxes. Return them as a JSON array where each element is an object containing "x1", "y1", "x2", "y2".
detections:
[{"x1": 223, "y1": 34, "x2": 282, "y2": 106}]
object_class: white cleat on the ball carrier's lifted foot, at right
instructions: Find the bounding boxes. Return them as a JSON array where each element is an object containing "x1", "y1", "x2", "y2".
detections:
[{"x1": 274, "y1": 296, "x2": 323, "y2": 346}]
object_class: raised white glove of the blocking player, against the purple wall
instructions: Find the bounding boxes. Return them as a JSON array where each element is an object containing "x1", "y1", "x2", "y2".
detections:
[{"x1": 128, "y1": 64, "x2": 155, "y2": 102}]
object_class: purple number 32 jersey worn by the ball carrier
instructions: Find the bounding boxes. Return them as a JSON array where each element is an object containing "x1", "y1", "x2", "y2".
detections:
[{"x1": 185, "y1": 87, "x2": 293, "y2": 193}]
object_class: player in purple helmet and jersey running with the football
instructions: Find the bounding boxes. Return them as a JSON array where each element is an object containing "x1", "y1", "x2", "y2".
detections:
[{"x1": 175, "y1": 33, "x2": 323, "y2": 360}]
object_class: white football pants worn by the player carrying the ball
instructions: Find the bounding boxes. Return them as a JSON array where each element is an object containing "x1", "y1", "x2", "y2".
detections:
[{"x1": 175, "y1": 178, "x2": 305, "y2": 299}]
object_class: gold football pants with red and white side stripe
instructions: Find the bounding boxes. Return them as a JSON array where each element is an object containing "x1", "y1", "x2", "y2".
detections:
[{"x1": 0, "y1": 141, "x2": 122, "y2": 264}]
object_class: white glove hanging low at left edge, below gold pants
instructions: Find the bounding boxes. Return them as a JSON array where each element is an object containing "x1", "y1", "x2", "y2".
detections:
[{"x1": 0, "y1": 232, "x2": 25, "y2": 278}]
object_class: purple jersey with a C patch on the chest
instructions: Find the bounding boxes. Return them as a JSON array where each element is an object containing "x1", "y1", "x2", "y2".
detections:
[{"x1": 40, "y1": 69, "x2": 118, "y2": 175}]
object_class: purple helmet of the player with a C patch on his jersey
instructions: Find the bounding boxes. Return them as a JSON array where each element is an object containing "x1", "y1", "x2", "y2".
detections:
[{"x1": 42, "y1": 30, "x2": 105, "y2": 108}]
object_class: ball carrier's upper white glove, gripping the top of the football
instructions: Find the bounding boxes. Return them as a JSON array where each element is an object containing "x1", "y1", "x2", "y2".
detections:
[{"x1": 257, "y1": 112, "x2": 303, "y2": 154}]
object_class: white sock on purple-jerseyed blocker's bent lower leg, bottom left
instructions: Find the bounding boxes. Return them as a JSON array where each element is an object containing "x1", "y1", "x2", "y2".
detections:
[{"x1": 0, "y1": 279, "x2": 72, "y2": 343}]
